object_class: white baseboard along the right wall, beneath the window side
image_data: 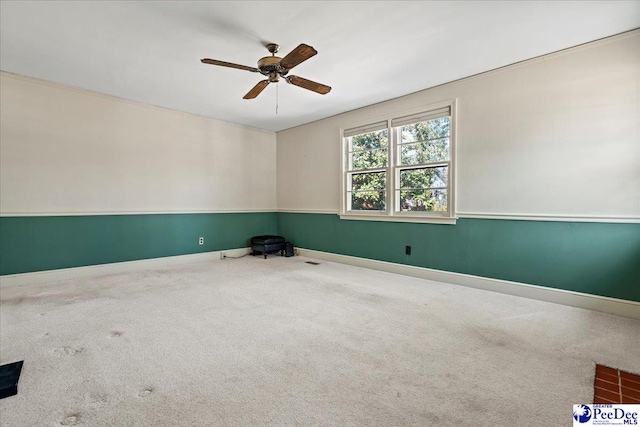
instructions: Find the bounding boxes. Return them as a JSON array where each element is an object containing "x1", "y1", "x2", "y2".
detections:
[{"x1": 297, "y1": 248, "x2": 640, "y2": 320}]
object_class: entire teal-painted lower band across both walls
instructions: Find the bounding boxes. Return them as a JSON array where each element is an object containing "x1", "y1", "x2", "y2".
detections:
[{"x1": 0, "y1": 212, "x2": 640, "y2": 302}]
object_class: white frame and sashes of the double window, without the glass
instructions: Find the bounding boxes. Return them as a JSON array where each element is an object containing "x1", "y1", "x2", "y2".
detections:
[{"x1": 340, "y1": 99, "x2": 457, "y2": 224}]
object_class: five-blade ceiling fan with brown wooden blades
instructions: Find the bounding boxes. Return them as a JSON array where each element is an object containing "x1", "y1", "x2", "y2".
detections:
[{"x1": 200, "y1": 43, "x2": 331, "y2": 99}]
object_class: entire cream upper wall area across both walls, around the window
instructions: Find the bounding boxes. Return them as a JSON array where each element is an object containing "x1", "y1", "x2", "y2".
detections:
[{"x1": 0, "y1": 31, "x2": 640, "y2": 218}]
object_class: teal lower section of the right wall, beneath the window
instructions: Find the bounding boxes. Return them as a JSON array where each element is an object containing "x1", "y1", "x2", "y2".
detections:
[{"x1": 277, "y1": 213, "x2": 640, "y2": 302}]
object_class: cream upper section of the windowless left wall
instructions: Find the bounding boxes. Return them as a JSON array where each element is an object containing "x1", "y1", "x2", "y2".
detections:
[{"x1": 0, "y1": 73, "x2": 276, "y2": 215}]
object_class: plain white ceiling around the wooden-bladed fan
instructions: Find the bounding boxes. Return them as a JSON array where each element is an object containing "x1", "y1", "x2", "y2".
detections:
[{"x1": 0, "y1": 0, "x2": 640, "y2": 131}]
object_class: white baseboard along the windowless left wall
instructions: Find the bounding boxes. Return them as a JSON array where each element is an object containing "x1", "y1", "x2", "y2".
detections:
[{"x1": 0, "y1": 248, "x2": 251, "y2": 288}]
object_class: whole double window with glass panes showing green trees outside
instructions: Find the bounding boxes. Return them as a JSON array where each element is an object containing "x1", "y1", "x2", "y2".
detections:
[{"x1": 341, "y1": 101, "x2": 455, "y2": 223}]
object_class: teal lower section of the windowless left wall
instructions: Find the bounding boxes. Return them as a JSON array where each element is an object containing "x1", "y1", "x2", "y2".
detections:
[{"x1": 0, "y1": 212, "x2": 277, "y2": 275}]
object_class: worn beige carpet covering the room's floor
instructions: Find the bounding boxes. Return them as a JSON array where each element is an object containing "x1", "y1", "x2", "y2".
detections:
[{"x1": 0, "y1": 257, "x2": 640, "y2": 426}]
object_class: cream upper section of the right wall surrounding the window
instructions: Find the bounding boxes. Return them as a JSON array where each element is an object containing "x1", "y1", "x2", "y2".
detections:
[{"x1": 277, "y1": 31, "x2": 640, "y2": 219}]
